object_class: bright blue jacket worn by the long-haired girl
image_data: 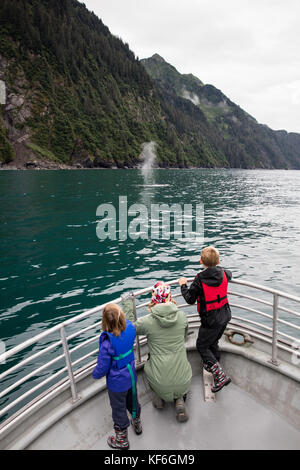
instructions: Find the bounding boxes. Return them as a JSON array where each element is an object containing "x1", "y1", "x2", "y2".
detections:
[{"x1": 92, "y1": 320, "x2": 137, "y2": 392}]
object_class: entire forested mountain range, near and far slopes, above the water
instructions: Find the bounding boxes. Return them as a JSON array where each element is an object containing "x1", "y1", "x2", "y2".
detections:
[{"x1": 0, "y1": 0, "x2": 300, "y2": 168}]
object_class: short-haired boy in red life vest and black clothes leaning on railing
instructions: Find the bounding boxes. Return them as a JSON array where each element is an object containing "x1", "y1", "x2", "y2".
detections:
[{"x1": 178, "y1": 246, "x2": 232, "y2": 393}]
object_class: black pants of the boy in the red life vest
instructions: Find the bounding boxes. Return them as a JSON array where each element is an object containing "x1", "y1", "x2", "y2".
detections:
[{"x1": 196, "y1": 320, "x2": 228, "y2": 367}]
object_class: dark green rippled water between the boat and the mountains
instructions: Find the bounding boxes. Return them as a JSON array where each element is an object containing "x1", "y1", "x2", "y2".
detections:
[{"x1": 0, "y1": 170, "x2": 300, "y2": 421}]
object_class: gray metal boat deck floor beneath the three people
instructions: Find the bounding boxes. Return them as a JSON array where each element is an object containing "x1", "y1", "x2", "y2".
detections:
[{"x1": 27, "y1": 374, "x2": 300, "y2": 450}]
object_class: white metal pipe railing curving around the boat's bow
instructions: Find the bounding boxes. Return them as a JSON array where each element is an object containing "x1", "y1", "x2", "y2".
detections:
[{"x1": 0, "y1": 279, "x2": 300, "y2": 430}]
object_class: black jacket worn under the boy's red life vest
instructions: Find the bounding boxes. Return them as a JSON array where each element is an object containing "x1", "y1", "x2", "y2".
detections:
[{"x1": 181, "y1": 266, "x2": 232, "y2": 318}]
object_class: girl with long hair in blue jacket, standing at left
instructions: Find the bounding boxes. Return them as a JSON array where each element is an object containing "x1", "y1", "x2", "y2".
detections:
[{"x1": 92, "y1": 304, "x2": 142, "y2": 449}]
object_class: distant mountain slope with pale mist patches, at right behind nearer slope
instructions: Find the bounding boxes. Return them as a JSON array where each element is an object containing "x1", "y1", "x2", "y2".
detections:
[{"x1": 141, "y1": 54, "x2": 300, "y2": 168}]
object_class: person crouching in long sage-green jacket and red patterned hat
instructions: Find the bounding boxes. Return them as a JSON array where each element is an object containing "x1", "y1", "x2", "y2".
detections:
[{"x1": 123, "y1": 281, "x2": 192, "y2": 422}]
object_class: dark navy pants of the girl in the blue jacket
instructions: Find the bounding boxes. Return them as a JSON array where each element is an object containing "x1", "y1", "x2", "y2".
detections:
[{"x1": 108, "y1": 388, "x2": 141, "y2": 429}]
